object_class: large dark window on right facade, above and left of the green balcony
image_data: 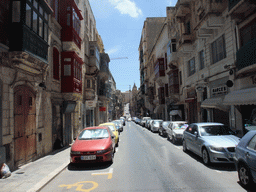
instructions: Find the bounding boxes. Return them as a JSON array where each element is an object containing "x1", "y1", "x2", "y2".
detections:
[{"x1": 211, "y1": 35, "x2": 226, "y2": 64}]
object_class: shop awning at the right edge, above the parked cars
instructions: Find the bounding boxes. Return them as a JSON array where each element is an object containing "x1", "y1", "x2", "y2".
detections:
[{"x1": 223, "y1": 87, "x2": 256, "y2": 105}]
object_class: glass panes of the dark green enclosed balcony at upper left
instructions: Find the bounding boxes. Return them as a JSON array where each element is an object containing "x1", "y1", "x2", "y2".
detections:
[{"x1": 25, "y1": 0, "x2": 49, "y2": 42}]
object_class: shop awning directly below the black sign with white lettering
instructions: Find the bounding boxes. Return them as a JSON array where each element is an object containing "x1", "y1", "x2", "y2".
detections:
[{"x1": 201, "y1": 97, "x2": 229, "y2": 111}]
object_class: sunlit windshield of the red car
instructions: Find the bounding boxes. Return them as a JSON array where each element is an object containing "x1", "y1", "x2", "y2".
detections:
[{"x1": 78, "y1": 129, "x2": 109, "y2": 140}]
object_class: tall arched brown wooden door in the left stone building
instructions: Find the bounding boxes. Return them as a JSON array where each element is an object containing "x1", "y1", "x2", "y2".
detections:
[{"x1": 14, "y1": 86, "x2": 36, "y2": 166}]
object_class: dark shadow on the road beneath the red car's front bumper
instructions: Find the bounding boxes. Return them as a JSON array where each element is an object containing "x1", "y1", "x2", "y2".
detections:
[{"x1": 68, "y1": 162, "x2": 112, "y2": 171}]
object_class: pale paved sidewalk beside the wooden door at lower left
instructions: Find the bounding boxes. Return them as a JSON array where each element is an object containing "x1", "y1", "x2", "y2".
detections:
[{"x1": 0, "y1": 147, "x2": 70, "y2": 192}]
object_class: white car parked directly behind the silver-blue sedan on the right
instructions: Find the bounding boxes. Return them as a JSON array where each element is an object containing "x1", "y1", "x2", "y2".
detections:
[{"x1": 167, "y1": 121, "x2": 188, "y2": 143}]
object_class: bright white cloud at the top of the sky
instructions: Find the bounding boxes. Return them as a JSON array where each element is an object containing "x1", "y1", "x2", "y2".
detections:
[{"x1": 109, "y1": 0, "x2": 142, "y2": 18}]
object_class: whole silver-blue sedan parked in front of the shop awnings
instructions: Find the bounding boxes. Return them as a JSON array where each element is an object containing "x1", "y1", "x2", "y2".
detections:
[{"x1": 183, "y1": 123, "x2": 240, "y2": 165}]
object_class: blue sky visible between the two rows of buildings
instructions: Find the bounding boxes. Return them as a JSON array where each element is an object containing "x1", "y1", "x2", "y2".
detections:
[{"x1": 89, "y1": 0, "x2": 177, "y2": 92}]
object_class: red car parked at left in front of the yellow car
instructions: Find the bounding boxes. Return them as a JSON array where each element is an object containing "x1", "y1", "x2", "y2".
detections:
[{"x1": 70, "y1": 127, "x2": 115, "y2": 163}]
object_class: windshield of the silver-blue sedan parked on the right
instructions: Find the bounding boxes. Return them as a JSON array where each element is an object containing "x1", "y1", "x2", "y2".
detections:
[{"x1": 200, "y1": 125, "x2": 234, "y2": 136}]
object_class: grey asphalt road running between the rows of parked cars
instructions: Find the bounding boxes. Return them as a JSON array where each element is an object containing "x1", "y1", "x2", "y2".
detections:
[{"x1": 41, "y1": 122, "x2": 246, "y2": 192}]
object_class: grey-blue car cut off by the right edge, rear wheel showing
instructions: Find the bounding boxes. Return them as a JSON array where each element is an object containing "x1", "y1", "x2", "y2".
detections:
[{"x1": 235, "y1": 130, "x2": 256, "y2": 187}]
